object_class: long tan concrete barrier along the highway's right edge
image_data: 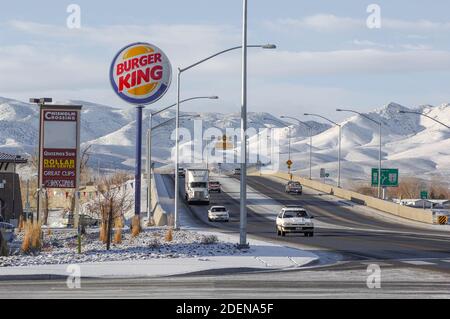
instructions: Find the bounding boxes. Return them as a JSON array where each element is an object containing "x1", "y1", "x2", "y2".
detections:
[{"x1": 263, "y1": 172, "x2": 435, "y2": 224}]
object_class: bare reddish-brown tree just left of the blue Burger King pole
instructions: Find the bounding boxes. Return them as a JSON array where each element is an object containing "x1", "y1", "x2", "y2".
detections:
[{"x1": 87, "y1": 173, "x2": 133, "y2": 250}]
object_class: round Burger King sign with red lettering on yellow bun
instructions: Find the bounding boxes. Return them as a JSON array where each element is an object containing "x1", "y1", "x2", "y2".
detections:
[{"x1": 109, "y1": 42, "x2": 172, "y2": 104}]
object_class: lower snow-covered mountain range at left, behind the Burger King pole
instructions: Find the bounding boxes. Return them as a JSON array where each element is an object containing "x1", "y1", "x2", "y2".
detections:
[{"x1": 0, "y1": 97, "x2": 329, "y2": 169}]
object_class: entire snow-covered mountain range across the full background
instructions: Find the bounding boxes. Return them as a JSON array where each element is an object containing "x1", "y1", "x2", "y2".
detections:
[{"x1": 0, "y1": 98, "x2": 450, "y2": 183}]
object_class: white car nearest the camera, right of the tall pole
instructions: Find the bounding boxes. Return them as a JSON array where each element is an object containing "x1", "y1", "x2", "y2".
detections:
[{"x1": 276, "y1": 206, "x2": 314, "y2": 237}]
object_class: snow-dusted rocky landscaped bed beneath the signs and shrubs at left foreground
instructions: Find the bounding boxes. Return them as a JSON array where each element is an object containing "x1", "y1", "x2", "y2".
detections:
[{"x1": 0, "y1": 227, "x2": 246, "y2": 267}]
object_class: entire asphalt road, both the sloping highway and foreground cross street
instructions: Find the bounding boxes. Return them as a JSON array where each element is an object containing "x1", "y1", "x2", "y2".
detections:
[{"x1": 0, "y1": 176, "x2": 450, "y2": 298}]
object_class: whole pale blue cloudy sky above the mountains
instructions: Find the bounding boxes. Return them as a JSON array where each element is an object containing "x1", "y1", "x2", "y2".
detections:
[{"x1": 0, "y1": 0, "x2": 450, "y2": 119}]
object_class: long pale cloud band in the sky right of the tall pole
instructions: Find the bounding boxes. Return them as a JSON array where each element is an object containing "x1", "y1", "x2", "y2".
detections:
[{"x1": 249, "y1": 49, "x2": 450, "y2": 77}]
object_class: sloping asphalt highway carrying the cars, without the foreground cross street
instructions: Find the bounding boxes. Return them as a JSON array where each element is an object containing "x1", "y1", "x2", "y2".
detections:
[{"x1": 178, "y1": 177, "x2": 450, "y2": 272}]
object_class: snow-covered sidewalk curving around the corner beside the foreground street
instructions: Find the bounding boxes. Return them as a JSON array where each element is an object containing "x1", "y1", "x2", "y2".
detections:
[{"x1": 0, "y1": 235, "x2": 318, "y2": 280}]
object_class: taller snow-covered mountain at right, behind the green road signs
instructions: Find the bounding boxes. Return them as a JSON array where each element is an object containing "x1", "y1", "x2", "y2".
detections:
[{"x1": 282, "y1": 103, "x2": 450, "y2": 185}]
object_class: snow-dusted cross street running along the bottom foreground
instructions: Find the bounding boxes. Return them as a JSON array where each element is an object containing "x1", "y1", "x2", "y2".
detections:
[{"x1": 0, "y1": 263, "x2": 450, "y2": 298}]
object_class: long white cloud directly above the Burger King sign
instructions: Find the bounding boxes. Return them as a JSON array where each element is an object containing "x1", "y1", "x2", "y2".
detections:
[{"x1": 7, "y1": 20, "x2": 241, "y2": 65}]
